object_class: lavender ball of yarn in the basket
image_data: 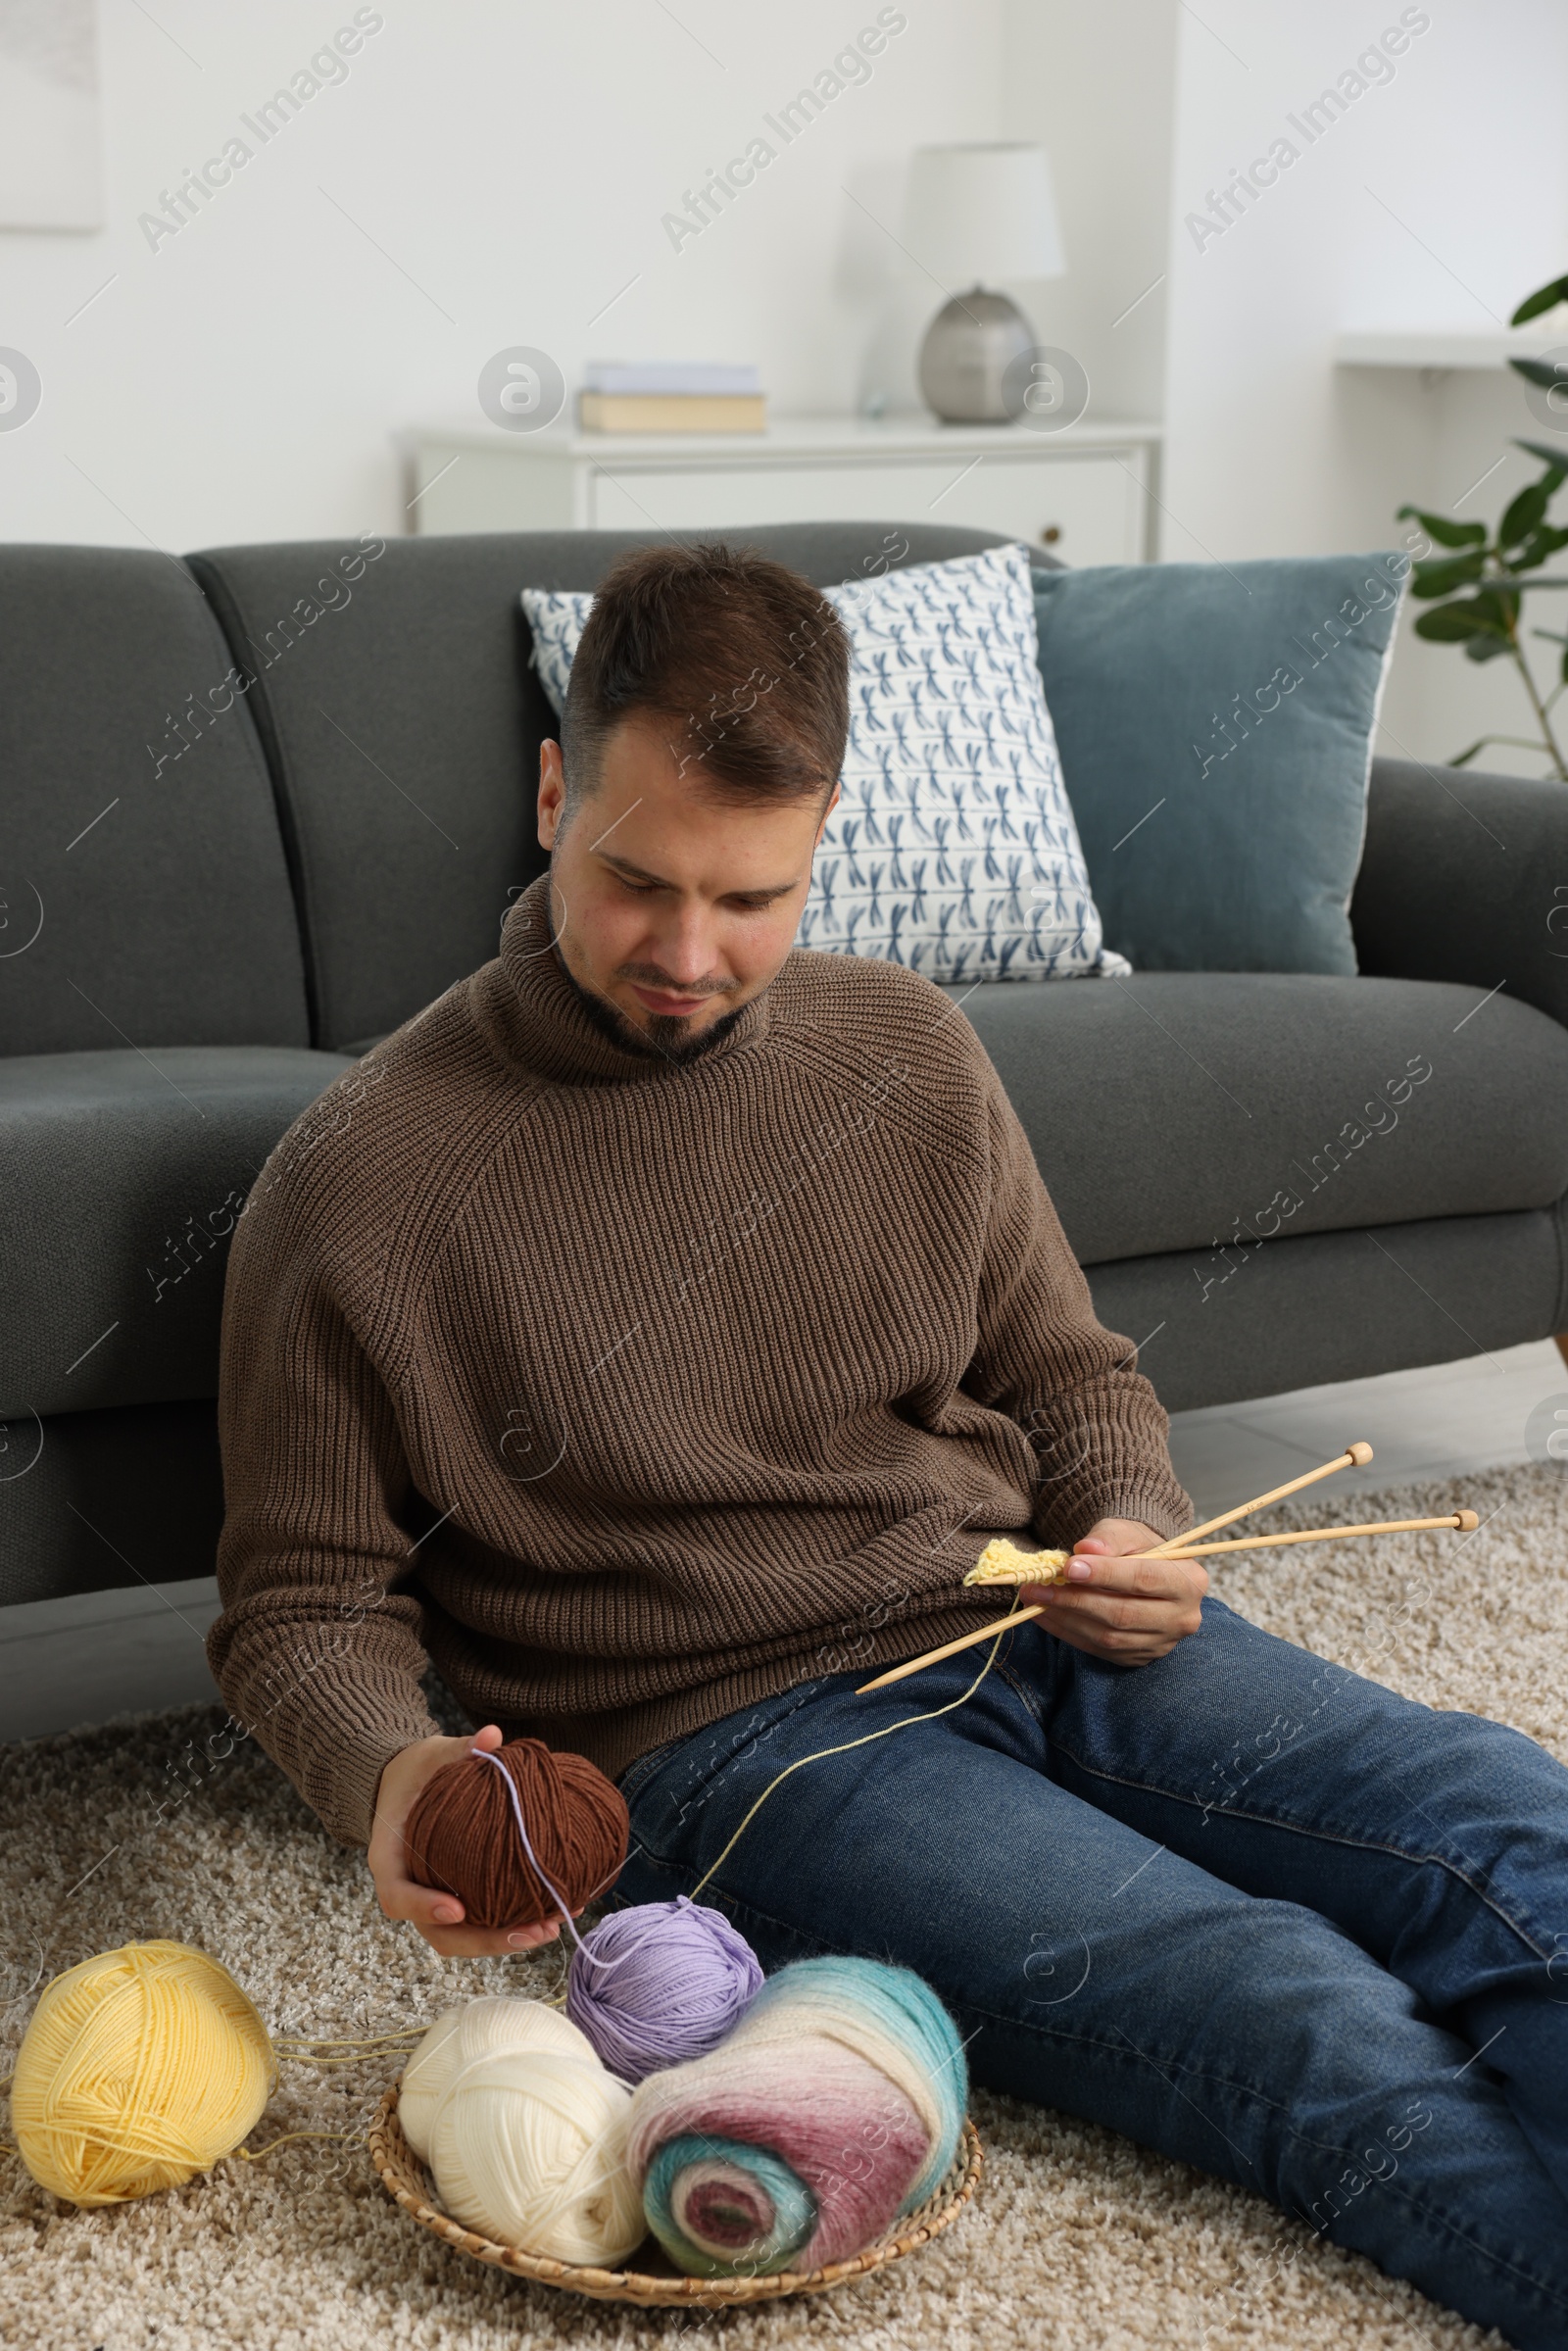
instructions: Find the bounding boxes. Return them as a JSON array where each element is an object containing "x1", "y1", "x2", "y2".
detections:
[{"x1": 566, "y1": 1895, "x2": 761, "y2": 2083}]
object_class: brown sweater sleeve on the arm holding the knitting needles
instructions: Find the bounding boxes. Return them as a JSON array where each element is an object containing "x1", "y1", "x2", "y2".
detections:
[{"x1": 964, "y1": 1060, "x2": 1192, "y2": 1549}]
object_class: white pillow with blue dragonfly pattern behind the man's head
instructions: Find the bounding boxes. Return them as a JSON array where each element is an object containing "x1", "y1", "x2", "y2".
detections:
[{"x1": 522, "y1": 546, "x2": 1133, "y2": 988}]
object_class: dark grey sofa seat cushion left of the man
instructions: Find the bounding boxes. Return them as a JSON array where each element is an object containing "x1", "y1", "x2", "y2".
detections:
[{"x1": 0, "y1": 1044, "x2": 348, "y2": 1422}]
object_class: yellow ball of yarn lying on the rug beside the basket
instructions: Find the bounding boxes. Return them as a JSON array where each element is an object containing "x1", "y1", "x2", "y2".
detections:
[{"x1": 12, "y1": 1942, "x2": 277, "y2": 2205}]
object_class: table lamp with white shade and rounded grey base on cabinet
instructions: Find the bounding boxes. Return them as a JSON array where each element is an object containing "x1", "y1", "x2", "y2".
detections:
[{"x1": 903, "y1": 146, "x2": 1067, "y2": 425}]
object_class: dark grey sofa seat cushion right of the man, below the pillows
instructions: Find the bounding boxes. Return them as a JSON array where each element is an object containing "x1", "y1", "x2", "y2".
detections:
[{"x1": 955, "y1": 971, "x2": 1568, "y2": 1274}]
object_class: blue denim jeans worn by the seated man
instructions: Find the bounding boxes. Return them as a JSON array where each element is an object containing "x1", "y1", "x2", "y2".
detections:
[{"x1": 618, "y1": 1598, "x2": 1568, "y2": 2351}]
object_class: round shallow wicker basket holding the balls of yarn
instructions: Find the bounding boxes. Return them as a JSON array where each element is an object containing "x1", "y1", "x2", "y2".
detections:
[{"x1": 369, "y1": 2085, "x2": 985, "y2": 2309}]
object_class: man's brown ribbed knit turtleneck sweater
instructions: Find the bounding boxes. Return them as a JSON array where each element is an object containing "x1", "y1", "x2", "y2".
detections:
[{"x1": 207, "y1": 879, "x2": 1190, "y2": 1843}]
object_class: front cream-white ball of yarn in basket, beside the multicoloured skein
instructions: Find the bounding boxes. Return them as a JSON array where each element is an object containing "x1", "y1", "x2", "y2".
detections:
[{"x1": 430, "y1": 2049, "x2": 647, "y2": 2269}]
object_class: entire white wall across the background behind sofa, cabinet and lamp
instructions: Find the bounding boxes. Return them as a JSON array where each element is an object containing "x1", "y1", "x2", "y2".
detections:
[{"x1": 12, "y1": 0, "x2": 1568, "y2": 768}]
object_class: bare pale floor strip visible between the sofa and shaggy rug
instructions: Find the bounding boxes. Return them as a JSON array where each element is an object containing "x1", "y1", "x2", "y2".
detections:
[{"x1": 0, "y1": 1340, "x2": 1568, "y2": 1739}]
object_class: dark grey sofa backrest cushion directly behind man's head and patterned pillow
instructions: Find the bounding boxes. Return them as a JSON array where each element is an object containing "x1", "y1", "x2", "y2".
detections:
[{"x1": 190, "y1": 522, "x2": 1006, "y2": 1049}]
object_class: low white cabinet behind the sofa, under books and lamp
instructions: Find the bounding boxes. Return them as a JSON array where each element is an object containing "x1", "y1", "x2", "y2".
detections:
[{"x1": 402, "y1": 418, "x2": 1159, "y2": 566}]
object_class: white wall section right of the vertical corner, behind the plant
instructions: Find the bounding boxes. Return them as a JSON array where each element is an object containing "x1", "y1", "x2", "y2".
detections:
[{"x1": 1161, "y1": 0, "x2": 1568, "y2": 773}]
